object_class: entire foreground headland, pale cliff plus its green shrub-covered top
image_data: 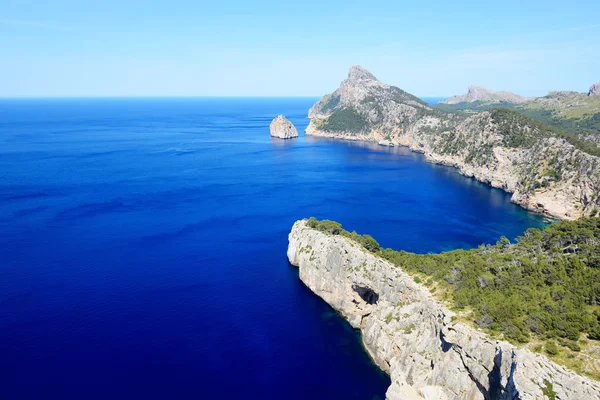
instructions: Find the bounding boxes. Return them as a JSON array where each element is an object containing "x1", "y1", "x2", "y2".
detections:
[{"x1": 287, "y1": 218, "x2": 600, "y2": 400}]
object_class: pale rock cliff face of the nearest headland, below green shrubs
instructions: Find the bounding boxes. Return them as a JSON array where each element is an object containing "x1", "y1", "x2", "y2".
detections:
[{"x1": 287, "y1": 221, "x2": 600, "y2": 400}]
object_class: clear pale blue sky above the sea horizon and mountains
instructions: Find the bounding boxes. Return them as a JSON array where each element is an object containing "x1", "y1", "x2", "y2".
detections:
[{"x1": 0, "y1": 0, "x2": 600, "y2": 97}]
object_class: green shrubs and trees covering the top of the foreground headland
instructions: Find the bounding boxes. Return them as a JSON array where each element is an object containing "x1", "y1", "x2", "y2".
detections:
[{"x1": 309, "y1": 218, "x2": 600, "y2": 344}]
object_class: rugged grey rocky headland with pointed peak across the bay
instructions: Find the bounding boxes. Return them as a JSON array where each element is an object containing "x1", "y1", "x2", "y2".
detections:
[{"x1": 306, "y1": 67, "x2": 600, "y2": 219}]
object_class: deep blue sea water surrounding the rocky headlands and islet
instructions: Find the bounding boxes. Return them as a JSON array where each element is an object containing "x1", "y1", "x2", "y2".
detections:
[{"x1": 0, "y1": 98, "x2": 542, "y2": 400}]
